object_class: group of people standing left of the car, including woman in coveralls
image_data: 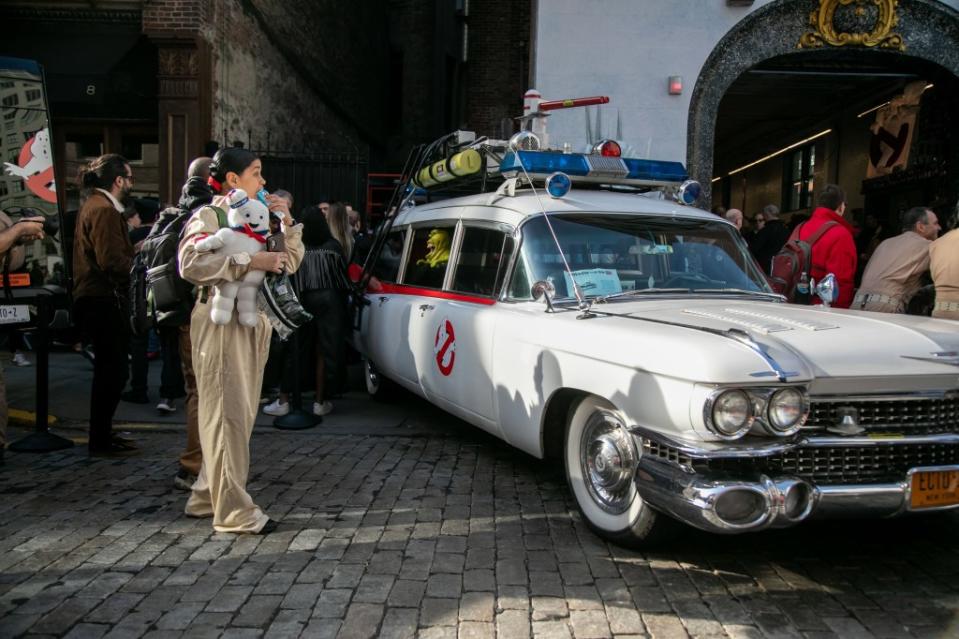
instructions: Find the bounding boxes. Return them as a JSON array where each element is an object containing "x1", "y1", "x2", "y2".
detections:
[{"x1": 62, "y1": 147, "x2": 363, "y2": 534}]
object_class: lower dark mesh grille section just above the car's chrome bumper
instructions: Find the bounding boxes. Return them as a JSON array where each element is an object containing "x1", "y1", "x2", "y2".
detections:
[{"x1": 693, "y1": 444, "x2": 959, "y2": 484}]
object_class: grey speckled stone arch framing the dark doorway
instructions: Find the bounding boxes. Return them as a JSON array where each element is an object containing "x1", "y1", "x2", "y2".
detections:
[{"x1": 686, "y1": 0, "x2": 959, "y2": 195}]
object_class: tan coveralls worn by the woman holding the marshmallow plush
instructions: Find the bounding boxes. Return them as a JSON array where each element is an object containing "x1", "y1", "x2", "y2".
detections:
[{"x1": 179, "y1": 202, "x2": 303, "y2": 533}]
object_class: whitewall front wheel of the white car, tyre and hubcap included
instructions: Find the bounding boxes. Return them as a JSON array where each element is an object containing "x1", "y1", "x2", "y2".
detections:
[{"x1": 564, "y1": 396, "x2": 668, "y2": 545}]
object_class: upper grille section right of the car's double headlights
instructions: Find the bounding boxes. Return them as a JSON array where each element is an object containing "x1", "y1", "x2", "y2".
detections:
[{"x1": 804, "y1": 394, "x2": 959, "y2": 434}]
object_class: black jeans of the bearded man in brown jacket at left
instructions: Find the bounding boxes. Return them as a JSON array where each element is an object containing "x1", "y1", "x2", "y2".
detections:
[{"x1": 73, "y1": 297, "x2": 130, "y2": 448}]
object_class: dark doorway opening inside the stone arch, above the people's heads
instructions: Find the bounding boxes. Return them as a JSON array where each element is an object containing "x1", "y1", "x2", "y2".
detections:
[{"x1": 712, "y1": 49, "x2": 959, "y2": 236}]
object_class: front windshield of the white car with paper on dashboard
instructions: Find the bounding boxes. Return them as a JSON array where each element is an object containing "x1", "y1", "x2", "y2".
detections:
[{"x1": 510, "y1": 213, "x2": 771, "y2": 299}]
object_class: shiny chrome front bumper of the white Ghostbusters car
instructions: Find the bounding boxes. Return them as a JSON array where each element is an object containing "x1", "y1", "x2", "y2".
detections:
[{"x1": 634, "y1": 430, "x2": 959, "y2": 533}]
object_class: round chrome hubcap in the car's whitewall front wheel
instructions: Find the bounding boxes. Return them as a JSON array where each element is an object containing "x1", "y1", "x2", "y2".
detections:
[{"x1": 580, "y1": 412, "x2": 636, "y2": 514}]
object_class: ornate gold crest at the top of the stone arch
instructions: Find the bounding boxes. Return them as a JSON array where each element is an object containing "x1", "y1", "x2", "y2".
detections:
[{"x1": 796, "y1": 0, "x2": 906, "y2": 51}]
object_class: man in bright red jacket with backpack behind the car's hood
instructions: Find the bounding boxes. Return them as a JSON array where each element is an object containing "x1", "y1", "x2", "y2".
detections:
[{"x1": 799, "y1": 184, "x2": 857, "y2": 308}]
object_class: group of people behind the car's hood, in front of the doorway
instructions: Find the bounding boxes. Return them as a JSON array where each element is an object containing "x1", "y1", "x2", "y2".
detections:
[{"x1": 713, "y1": 184, "x2": 959, "y2": 319}]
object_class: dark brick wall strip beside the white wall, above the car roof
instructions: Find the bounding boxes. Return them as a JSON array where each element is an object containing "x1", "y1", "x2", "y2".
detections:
[{"x1": 465, "y1": 0, "x2": 531, "y2": 138}]
